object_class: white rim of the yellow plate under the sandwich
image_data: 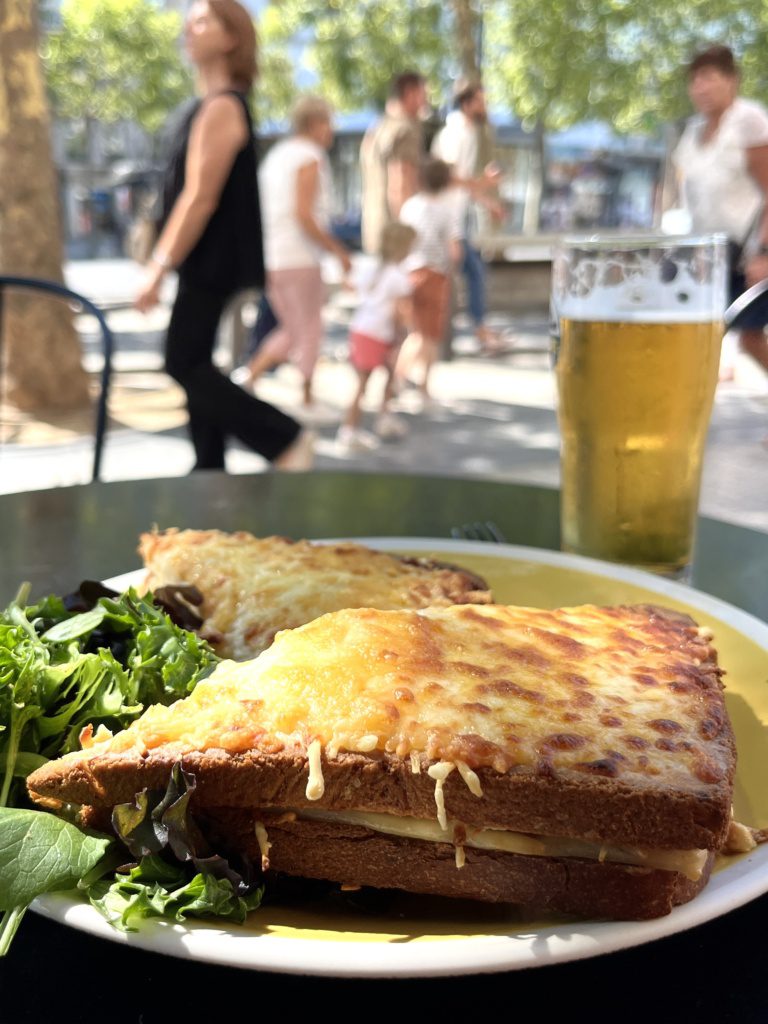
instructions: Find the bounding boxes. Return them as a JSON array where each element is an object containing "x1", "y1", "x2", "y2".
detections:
[{"x1": 33, "y1": 537, "x2": 768, "y2": 978}]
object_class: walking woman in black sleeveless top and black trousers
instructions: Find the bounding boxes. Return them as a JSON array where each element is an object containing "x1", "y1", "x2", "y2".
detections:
[{"x1": 135, "y1": 0, "x2": 311, "y2": 469}]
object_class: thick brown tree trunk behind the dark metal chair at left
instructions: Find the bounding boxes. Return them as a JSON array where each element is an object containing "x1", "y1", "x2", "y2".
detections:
[{"x1": 0, "y1": 0, "x2": 88, "y2": 412}]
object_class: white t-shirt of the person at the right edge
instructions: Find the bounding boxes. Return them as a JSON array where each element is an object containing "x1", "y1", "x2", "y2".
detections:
[{"x1": 672, "y1": 97, "x2": 768, "y2": 243}]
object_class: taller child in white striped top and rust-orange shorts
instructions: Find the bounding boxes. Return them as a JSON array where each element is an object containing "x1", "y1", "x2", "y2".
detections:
[{"x1": 397, "y1": 159, "x2": 462, "y2": 399}]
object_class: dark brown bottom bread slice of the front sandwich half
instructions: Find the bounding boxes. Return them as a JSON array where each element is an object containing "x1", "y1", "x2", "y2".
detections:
[{"x1": 75, "y1": 807, "x2": 715, "y2": 921}]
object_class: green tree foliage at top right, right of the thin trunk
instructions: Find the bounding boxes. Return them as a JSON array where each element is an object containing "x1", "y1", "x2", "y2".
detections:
[{"x1": 484, "y1": 0, "x2": 768, "y2": 131}]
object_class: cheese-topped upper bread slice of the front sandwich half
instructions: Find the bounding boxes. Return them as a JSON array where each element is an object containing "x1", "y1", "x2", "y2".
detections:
[{"x1": 29, "y1": 605, "x2": 735, "y2": 850}]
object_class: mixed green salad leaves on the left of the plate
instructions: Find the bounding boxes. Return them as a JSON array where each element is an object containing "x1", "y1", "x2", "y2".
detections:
[{"x1": 0, "y1": 584, "x2": 239, "y2": 955}]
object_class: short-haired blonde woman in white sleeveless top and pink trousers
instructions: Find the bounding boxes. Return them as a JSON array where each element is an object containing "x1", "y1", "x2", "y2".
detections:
[{"x1": 246, "y1": 96, "x2": 350, "y2": 408}]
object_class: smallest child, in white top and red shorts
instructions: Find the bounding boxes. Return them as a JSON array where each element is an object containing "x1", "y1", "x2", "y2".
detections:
[{"x1": 336, "y1": 221, "x2": 416, "y2": 450}]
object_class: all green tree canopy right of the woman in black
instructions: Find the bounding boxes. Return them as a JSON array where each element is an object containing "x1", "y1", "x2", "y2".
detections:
[{"x1": 257, "y1": 0, "x2": 768, "y2": 131}]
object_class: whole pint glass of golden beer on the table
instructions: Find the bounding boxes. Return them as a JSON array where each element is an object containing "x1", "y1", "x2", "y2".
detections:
[{"x1": 553, "y1": 236, "x2": 727, "y2": 578}]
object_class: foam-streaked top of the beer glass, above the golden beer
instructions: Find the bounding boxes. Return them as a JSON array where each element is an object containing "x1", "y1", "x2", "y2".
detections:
[{"x1": 552, "y1": 236, "x2": 726, "y2": 324}]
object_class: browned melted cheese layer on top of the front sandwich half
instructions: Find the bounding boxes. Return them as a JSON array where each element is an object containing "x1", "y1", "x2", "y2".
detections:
[{"x1": 79, "y1": 605, "x2": 730, "y2": 790}]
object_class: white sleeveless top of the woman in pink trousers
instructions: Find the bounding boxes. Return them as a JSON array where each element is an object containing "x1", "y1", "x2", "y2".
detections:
[{"x1": 259, "y1": 135, "x2": 331, "y2": 270}]
